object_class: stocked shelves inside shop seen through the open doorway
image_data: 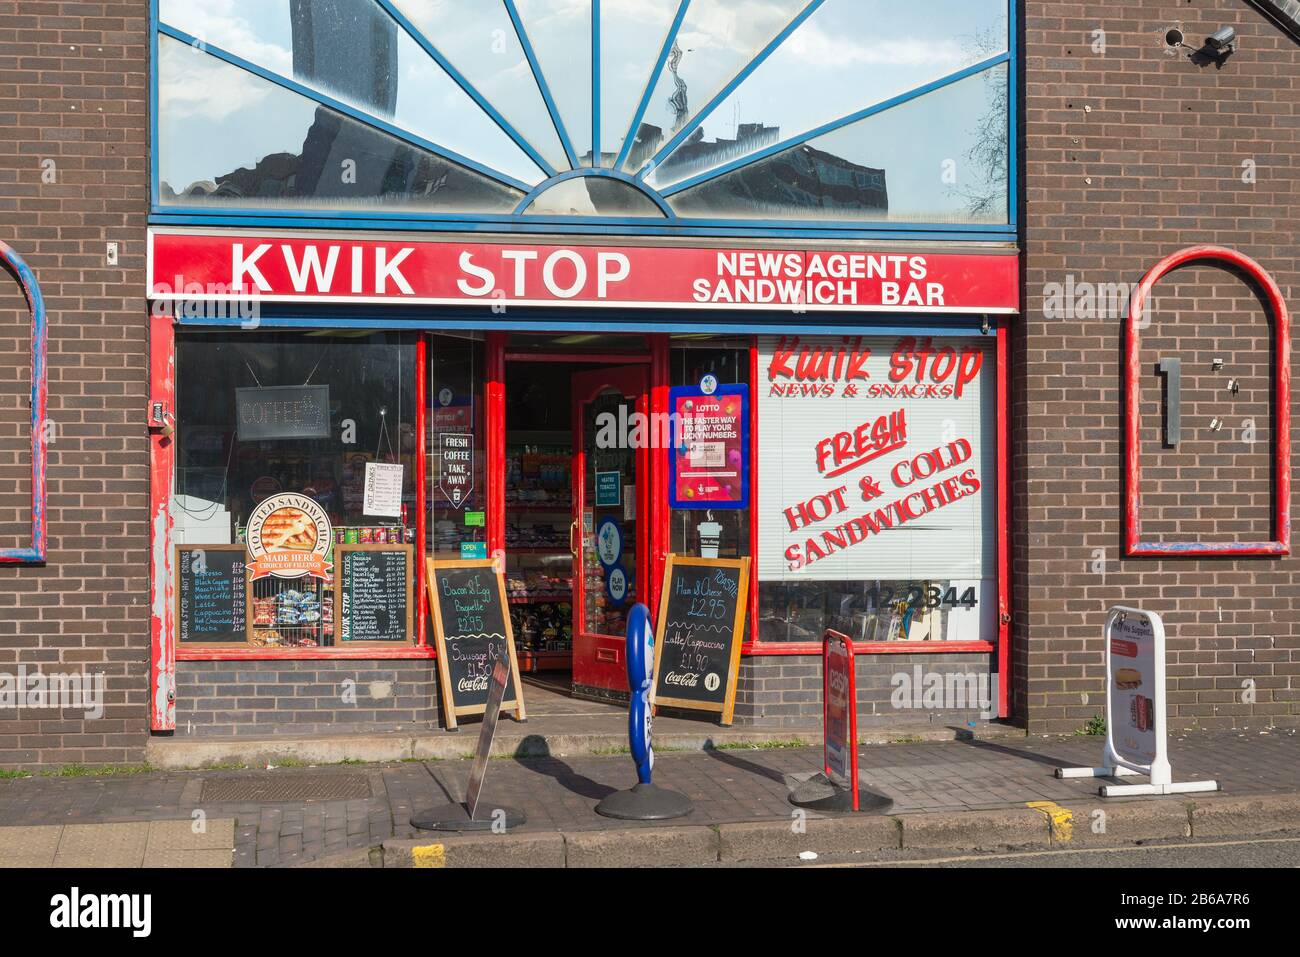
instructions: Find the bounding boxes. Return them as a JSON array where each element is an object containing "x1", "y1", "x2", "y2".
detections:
[{"x1": 506, "y1": 432, "x2": 573, "y2": 671}]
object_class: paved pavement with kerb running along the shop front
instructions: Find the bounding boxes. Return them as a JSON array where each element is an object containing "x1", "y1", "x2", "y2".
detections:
[{"x1": 0, "y1": 729, "x2": 1300, "y2": 867}]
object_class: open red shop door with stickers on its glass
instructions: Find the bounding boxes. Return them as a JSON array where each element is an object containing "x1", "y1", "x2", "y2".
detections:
[{"x1": 569, "y1": 364, "x2": 650, "y2": 697}]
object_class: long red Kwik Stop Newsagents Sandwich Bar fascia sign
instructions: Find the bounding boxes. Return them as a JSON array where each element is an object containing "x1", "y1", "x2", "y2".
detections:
[{"x1": 148, "y1": 229, "x2": 1019, "y2": 313}]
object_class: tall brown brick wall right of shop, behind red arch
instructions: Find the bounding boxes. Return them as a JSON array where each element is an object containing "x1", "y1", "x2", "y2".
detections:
[{"x1": 1011, "y1": 0, "x2": 1300, "y2": 732}]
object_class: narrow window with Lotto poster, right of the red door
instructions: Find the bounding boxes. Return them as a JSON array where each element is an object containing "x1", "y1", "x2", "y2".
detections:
[{"x1": 668, "y1": 335, "x2": 754, "y2": 641}]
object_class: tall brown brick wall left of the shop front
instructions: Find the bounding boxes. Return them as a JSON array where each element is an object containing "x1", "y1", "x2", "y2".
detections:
[{"x1": 0, "y1": 0, "x2": 148, "y2": 766}]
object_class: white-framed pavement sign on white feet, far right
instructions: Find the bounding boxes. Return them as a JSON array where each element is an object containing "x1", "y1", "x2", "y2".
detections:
[{"x1": 1057, "y1": 605, "x2": 1218, "y2": 797}]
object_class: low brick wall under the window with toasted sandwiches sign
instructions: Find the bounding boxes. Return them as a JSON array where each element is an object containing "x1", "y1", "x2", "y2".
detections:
[{"x1": 176, "y1": 661, "x2": 439, "y2": 736}]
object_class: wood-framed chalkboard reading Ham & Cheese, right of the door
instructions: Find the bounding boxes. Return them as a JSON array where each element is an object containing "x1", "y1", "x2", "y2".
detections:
[{"x1": 651, "y1": 555, "x2": 749, "y2": 724}]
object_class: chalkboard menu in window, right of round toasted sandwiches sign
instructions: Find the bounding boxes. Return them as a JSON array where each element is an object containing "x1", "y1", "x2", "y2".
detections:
[{"x1": 334, "y1": 545, "x2": 415, "y2": 645}]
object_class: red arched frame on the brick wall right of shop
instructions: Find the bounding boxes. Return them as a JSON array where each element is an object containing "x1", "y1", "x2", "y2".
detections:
[{"x1": 1125, "y1": 246, "x2": 1291, "y2": 555}]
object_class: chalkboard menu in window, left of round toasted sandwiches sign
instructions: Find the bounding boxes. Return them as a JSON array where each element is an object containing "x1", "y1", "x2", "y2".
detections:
[{"x1": 176, "y1": 545, "x2": 248, "y2": 645}]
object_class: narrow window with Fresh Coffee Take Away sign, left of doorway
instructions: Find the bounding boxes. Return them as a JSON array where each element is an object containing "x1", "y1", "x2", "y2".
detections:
[{"x1": 426, "y1": 333, "x2": 490, "y2": 560}]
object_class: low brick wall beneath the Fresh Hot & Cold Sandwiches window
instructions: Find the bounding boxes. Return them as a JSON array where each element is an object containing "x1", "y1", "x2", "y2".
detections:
[{"x1": 736, "y1": 654, "x2": 997, "y2": 731}]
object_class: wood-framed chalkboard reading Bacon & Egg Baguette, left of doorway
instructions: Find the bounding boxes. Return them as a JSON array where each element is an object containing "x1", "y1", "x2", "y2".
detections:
[{"x1": 425, "y1": 558, "x2": 525, "y2": 728}]
